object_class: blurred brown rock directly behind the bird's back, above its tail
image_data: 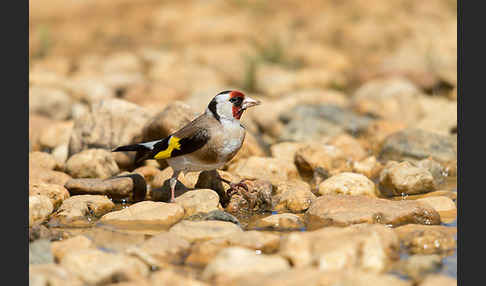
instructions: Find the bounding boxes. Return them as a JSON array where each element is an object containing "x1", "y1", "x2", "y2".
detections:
[{"x1": 141, "y1": 101, "x2": 198, "y2": 142}]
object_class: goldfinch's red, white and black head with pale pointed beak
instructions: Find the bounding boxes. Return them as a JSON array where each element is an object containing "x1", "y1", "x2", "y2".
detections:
[{"x1": 206, "y1": 90, "x2": 260, "y2": 121}]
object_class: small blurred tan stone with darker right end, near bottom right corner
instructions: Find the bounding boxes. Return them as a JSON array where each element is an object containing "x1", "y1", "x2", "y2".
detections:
[{"x1": 394, "y1": 254, "x2": 442, "y2": 281}]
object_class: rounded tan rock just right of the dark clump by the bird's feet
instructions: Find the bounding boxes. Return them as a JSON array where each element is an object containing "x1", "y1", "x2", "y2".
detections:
[{"x1": 274, "y1": 181, "x2": 316, "y2": 213}]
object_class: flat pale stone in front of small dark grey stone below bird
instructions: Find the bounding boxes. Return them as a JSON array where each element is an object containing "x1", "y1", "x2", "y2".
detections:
[{"x1": 169, "y1": 220, "x2": 242, "y2": 243}]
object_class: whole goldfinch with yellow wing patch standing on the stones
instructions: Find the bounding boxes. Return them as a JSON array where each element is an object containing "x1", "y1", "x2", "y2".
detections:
[{"x1": 112, "y1": 90, "x2": 261, "y2": 203}]
